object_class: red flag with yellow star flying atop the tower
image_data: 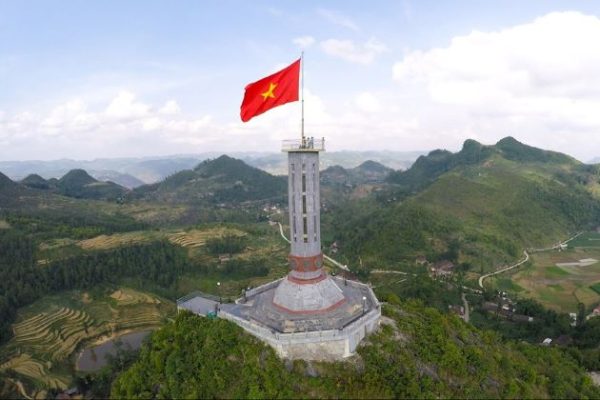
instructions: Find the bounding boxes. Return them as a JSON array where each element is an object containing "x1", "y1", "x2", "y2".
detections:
[{"x1": 240, "y1": 59, "x2": 300, "y2": 122}]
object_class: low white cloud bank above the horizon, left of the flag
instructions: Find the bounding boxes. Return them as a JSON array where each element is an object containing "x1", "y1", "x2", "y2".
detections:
[{"x1": 0, "y1": 91, "x2": 222, "y2": 159}]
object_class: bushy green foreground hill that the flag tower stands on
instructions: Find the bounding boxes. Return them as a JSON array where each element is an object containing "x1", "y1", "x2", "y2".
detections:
[{"x1": 112, "y1": 302, "x2": 600, "y2": 398}]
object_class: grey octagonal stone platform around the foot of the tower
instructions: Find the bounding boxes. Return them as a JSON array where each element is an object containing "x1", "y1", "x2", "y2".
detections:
[{"x1": 219, "y1": 277, "x2": 381, "y2": 360}]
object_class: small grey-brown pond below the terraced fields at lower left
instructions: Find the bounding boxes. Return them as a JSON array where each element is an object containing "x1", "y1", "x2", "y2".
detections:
[{"x1": 77, "y1": 331, "x2": 152, "y2": 372}]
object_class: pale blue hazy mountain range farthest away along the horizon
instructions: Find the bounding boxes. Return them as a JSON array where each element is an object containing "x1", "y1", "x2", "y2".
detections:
[{"x1": 0, "y1": 151, "x2": 424, "y2": 189}]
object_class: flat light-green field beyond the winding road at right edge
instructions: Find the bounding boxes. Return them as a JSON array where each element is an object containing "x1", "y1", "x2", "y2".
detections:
[{"x1": 490, "y1": 242, "x2": 600, "y2": 312}]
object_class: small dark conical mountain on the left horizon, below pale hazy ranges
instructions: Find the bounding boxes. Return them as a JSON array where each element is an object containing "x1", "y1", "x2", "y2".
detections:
[{"x1": 56, "y1": 169, "x2": 127, "y2": 200}]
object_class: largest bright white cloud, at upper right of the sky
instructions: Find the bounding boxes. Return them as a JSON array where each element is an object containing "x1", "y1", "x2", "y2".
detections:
[{"x1": 393, "y1": 12, "x2": 600, "y2": 158}]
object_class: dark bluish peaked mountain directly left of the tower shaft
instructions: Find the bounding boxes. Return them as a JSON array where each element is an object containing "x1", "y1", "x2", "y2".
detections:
[{"x1": 132, "y1": 155, "x2": 287, "y2": 204}]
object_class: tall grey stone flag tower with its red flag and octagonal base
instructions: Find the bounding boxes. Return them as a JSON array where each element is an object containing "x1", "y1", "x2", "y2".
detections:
[{"x1": 177, "y1": 54, "x2": 381, "y2": 360}]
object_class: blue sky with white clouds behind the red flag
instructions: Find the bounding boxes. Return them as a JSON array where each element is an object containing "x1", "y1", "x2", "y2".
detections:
[{"x1": 0, "y1": 1, "x2": 600, "y2": 160}]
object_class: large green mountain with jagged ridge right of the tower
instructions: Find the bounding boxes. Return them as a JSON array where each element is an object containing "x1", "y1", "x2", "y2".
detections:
[{"x1": 328, "y1": 137, "x2": 600, "y2": 272}]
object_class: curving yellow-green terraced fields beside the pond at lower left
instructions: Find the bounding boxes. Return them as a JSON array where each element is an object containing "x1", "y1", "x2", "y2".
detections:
[{"x1": 0, "y1": 287, "x2": 175, "y2": 397}]
